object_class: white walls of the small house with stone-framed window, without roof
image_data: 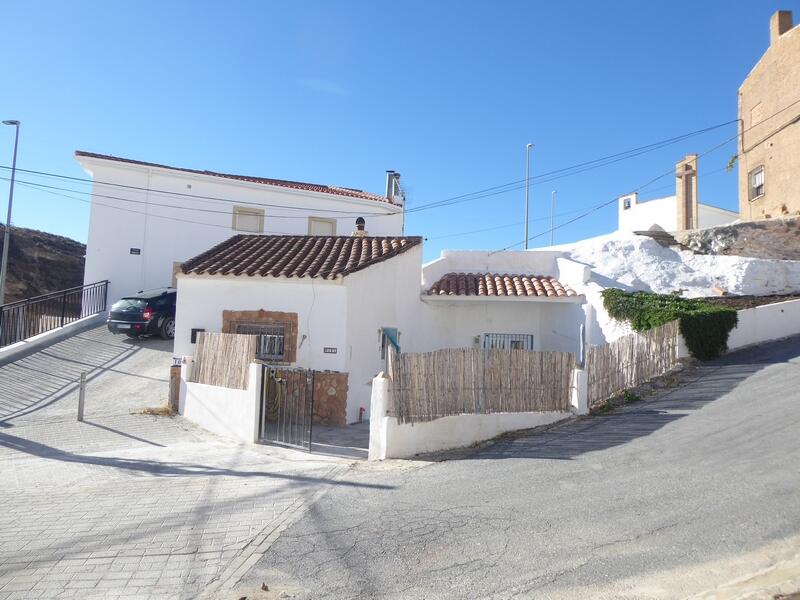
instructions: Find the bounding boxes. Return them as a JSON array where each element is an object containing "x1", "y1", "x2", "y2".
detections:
[{"x1": 174, "y1": 246, "x2": 422, "y2": 423}]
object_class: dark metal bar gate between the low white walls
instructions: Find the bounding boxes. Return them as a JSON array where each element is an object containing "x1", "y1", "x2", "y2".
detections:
[{"x1": 259, "y1": 365, "x2": 314, "y2": 451}]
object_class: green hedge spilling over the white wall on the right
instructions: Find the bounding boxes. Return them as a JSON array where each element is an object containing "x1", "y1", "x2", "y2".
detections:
[{"x1": 603, "y1": 288, "x2": 738, "y2": 360}]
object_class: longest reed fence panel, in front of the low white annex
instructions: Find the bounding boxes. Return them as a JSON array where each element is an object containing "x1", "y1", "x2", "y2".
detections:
[{"x1": 389, "y1": 348, "x2": 575, "y2": 423}]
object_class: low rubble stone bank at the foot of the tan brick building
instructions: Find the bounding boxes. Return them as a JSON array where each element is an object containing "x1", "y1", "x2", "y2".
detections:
[{"x1": 674, "y1": 217, "x2": 800, "y2": 260}]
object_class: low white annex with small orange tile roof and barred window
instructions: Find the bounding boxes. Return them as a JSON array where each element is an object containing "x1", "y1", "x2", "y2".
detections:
[{"x1": 416, "y1": 251, "x2": 585, "y2": 354}]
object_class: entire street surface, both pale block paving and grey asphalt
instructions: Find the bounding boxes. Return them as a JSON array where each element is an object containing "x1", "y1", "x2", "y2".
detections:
[{"x1": 0, "y1": 328, "x2": 800, "y2": 600}]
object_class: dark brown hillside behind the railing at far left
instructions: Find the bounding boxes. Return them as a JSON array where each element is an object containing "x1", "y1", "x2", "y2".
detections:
[{"x1": 0, "y1": 224, "x2": 86, "y2": 302}]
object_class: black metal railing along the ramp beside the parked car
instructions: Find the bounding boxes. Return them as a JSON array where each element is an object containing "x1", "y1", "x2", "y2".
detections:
[{"x1": 0, "y1": 281, "x2": 108, "y2": 348}]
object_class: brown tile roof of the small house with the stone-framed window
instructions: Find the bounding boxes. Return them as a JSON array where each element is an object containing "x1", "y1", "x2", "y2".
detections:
[{"x1": 181, "y1": 235, "x2": 422, "y2": 279}]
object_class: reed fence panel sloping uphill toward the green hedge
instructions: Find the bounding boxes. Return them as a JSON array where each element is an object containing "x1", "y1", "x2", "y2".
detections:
[{"x1": 586, "y1": 321, "x2": 678, "y2": 406}]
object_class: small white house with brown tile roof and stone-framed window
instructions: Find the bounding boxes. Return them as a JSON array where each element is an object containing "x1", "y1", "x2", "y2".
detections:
[{"x1": 174, "y1": 235, "x2": 422, "y2": 425}]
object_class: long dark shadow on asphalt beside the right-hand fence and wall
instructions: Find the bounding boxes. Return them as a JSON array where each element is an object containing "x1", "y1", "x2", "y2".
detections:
[{"x1": 468, "y1": 337, "x2": 800, "y2": 460}]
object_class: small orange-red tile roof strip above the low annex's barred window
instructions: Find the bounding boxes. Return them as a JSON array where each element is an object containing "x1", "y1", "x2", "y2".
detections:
[{"x1": 427, "y1": 273, "x2": 578, "y2": 298}]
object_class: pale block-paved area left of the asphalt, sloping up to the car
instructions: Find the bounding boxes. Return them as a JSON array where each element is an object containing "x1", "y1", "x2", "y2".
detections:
[{"x1": 0, "y1": 328, "x2": 368, "y2": 599}]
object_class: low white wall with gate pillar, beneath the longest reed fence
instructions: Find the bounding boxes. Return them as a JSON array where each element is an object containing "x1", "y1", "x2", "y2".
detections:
[{"x1": 369, "y1": 373, "x2": 571, "y2": 460}]
